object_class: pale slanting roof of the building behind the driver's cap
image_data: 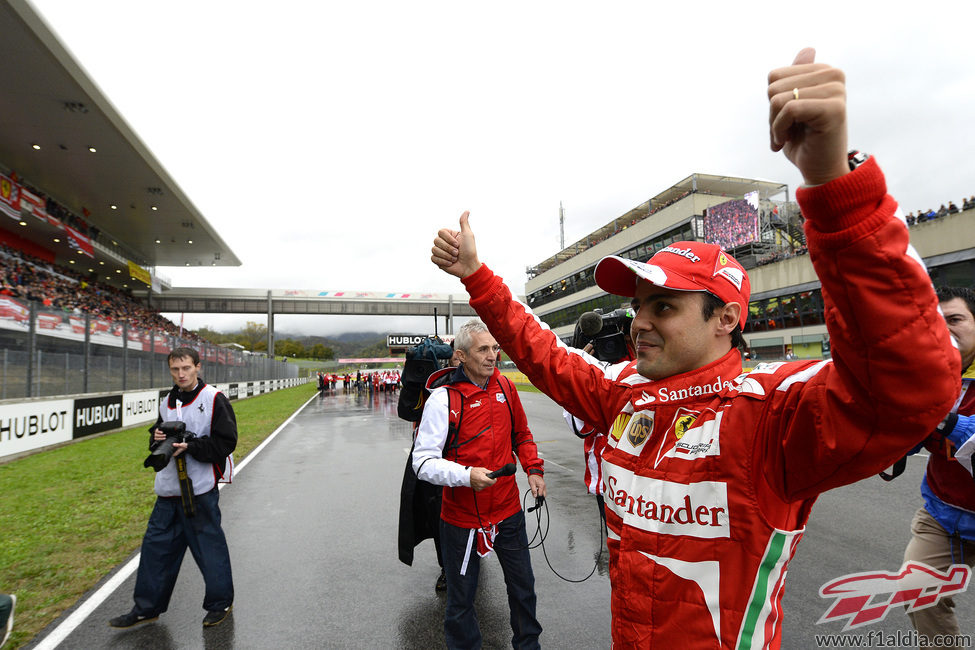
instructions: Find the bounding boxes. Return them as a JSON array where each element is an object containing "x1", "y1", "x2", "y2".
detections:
[{"x1": 529, "y1": 174, "x2": 789, "y2": 273}]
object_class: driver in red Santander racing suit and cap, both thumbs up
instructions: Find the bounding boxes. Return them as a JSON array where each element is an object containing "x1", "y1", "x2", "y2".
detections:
[{"x1": 432, "y1": 50, "x2": 960, "y2": 648}]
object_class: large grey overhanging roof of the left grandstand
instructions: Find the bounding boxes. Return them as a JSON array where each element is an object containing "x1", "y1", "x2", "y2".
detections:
[{"x1": 0, "y1": 0, "x2": 240, "y2": 277}]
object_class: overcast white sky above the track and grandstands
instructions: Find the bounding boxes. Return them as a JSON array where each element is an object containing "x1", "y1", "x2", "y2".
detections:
[{"x1": 26, "y1": 0, "x2": 975, "y2": 334}]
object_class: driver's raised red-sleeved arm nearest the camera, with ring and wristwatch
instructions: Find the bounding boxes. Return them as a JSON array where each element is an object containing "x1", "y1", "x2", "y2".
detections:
[{"x1": 765, "y1": 50, "x2": 960, "y2": 499}]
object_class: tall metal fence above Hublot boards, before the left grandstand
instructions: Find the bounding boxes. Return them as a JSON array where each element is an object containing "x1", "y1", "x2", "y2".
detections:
[{"x1": 0, "y1": 296, "x2": 298, "y2": 399}]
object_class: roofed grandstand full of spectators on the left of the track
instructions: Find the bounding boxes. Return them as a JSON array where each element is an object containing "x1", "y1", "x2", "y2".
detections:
[{"x1": 0, "y1": 0, "x2": 291, "y2": 399}]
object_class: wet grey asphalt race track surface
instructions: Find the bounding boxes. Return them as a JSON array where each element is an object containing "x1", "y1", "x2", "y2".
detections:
[{"x1": 28, "y1": 389, "x2": 975, "y2": 650}]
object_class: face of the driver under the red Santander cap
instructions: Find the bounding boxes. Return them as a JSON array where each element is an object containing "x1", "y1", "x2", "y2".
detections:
[{"x1": 630, "y1": 282, "x2": 730, "y2": 380}]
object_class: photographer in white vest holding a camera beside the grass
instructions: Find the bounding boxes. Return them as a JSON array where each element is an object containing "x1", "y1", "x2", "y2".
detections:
[{"x1": 109, "y1": 347, "x2": 237, "y2": 627}]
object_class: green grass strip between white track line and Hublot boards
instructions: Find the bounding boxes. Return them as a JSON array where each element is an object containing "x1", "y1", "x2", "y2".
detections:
[{"x1": 0, "y1": 382, "x2": 316, "y2": 650}]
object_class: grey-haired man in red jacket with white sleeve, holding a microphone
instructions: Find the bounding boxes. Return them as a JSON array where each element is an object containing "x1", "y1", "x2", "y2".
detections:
[{"x1": 413, "y1": 319, "x2": 545, "y2": 648}]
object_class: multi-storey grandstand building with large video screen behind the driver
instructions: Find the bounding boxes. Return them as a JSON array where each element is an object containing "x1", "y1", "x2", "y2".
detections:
[{"x1": 525, "y1": 174, "x2": 975, "y2": 359}]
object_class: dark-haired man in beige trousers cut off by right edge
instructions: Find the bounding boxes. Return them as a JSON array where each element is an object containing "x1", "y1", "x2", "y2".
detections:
[{"x1": 904, "y1": 287, "x2": 975, "y2": 646}]
